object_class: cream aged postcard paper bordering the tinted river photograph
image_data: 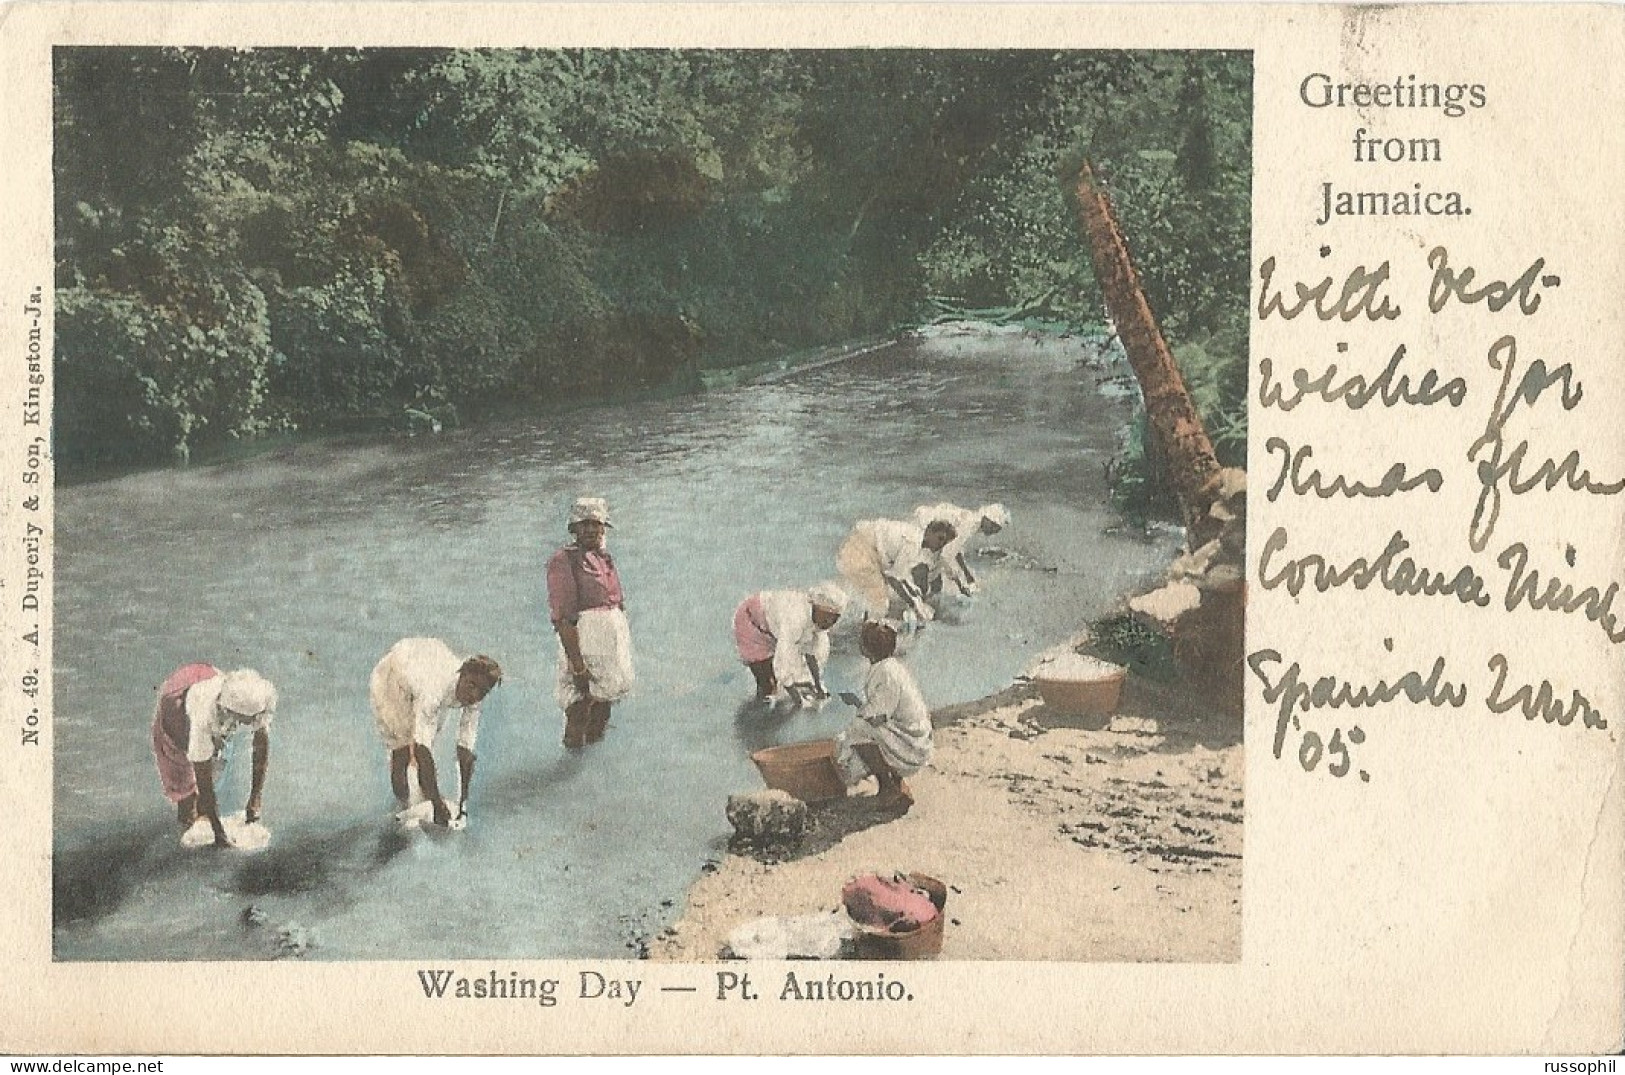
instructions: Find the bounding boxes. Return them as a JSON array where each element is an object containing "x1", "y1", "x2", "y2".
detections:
[{"x1": 0, "y1": 3, "x2": 1625, "y2": 1054}]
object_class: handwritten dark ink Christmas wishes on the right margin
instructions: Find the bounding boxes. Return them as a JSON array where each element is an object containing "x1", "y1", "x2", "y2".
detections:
[{"x1": 1246, "y1": 145, "x2": 1625, "y2": 783}]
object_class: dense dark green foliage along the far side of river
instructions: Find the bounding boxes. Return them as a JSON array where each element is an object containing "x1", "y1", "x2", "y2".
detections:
[{"x1": 55, "y1": 47, "x2": 1251, "y2": 468}]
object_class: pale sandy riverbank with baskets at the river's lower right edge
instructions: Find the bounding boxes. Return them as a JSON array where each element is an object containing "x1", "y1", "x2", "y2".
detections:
[{"x1": 650, "y1": 679, "x2": 1243, "y2": 961}]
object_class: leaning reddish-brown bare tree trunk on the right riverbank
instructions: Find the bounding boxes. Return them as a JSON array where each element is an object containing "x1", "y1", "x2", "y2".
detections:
[{"x1": 1077, "y1": 161, "x2": 1219, "y2": 528}]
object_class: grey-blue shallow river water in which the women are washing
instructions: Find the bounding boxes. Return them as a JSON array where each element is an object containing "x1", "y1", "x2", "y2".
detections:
[{"x1": 54, "y1": 331, "x2": 1173, "y2": 960}]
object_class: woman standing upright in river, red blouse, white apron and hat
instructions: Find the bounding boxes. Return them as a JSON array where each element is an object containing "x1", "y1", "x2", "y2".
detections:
[{"x1": 548, "y1": 497, "x2": 634, "y2": 750}]
